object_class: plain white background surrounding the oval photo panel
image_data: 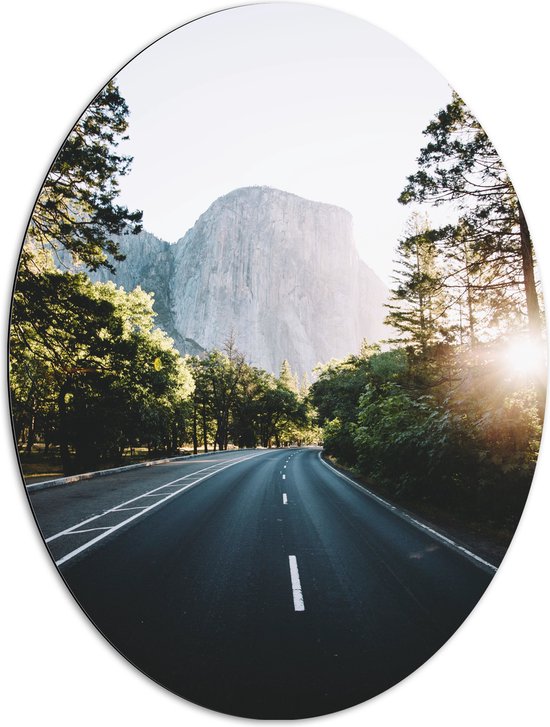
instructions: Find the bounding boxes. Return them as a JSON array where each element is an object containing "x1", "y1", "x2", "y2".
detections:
[{"x1": 0, "y1": 0, "x2": 550, "y2": 727}]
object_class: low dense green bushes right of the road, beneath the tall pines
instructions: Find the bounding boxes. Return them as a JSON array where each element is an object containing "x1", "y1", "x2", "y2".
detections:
[{"x1": 309, "y1": 338, "x2": 541, "y2": 524}]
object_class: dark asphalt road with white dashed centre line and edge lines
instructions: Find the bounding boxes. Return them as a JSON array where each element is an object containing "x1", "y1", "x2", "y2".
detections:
[{"x1": 31, "y1": 448, "x2": 494, "y2": 719}]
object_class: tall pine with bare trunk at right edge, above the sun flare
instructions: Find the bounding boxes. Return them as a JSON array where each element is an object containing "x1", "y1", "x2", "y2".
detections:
[{"x1": 399, "y1": 93, "x2": 546, "y2": 421}]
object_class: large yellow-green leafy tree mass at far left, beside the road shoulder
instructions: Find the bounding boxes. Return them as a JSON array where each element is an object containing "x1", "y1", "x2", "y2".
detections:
[{"x1": 10, "y1": 262, "x2": 192, "y2": 472}]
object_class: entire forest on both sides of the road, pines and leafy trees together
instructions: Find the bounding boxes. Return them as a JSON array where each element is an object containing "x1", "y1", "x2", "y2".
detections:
[{"x1": 10, "y1": 82, "x2": 546, "y2": 524}]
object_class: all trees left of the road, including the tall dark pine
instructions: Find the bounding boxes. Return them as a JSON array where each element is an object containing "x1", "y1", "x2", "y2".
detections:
[{"x1": 10, "y1": 82, "x2": 314, "y2": 473}]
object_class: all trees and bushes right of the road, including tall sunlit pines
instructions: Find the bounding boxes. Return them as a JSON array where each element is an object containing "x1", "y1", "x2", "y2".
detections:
[{"x1": 311, "y1": 95, "x2": 546, "y2": 523}]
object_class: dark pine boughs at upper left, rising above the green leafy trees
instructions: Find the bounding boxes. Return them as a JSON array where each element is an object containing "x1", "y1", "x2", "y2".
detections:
[{"x1": 25, "y1": 81, "x2": 142, "y2": 270}]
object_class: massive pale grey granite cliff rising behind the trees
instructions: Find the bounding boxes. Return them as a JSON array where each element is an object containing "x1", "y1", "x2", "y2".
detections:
[{"x1": 94, "y1": 187, "x2": 387, "y2": 375}]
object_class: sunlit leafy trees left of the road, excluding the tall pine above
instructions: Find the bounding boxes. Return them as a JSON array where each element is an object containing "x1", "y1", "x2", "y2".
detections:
[{"x1": 10, "y1": 256, "x2": 312, "y2": 474}]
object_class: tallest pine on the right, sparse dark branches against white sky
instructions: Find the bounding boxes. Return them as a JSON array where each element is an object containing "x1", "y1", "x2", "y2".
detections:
[{"x1": 399, "y1": 93, "x2": 542, "y2": 341}]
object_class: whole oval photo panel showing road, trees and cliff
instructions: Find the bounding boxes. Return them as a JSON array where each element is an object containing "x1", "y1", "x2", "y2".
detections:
[{"x1": 10, "y1": 3, "x2": 546, "y2": 719}]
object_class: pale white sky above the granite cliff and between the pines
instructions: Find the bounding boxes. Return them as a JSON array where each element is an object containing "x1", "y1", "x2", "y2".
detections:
[{"x1": 117, "y1": 3, "x2": 451, "y2": 282}]
